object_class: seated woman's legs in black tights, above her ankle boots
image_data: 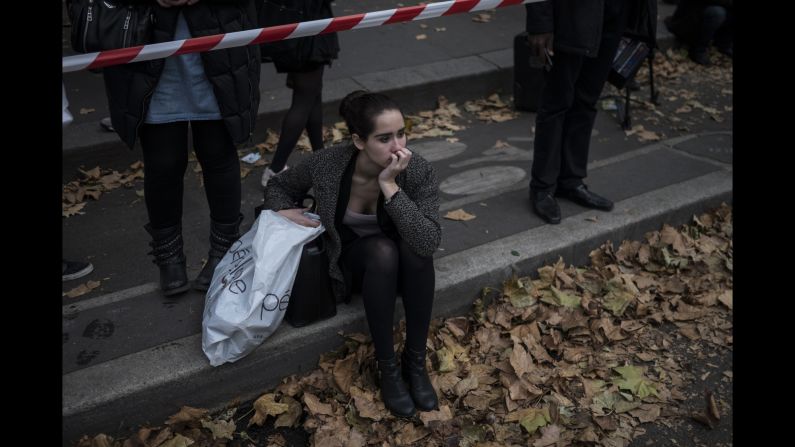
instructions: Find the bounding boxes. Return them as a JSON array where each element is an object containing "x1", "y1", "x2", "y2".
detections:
[{"x1": 342, "y1": 234, "x2": 436, "y2": 360}]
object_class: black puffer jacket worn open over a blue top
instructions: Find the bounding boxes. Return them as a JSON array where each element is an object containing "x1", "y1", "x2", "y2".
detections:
[{"x1": 103, "y1": 0, "x2": 260, "y2": 149}]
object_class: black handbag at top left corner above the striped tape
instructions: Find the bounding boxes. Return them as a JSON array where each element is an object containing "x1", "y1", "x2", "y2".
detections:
[{"x1": 67, "y1": 0, "x2": 154, "y2": 53}]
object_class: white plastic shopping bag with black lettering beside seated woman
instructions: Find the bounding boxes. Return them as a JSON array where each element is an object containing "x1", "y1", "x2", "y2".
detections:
[{"x1": 202, "y1": 210, "x2": 324, "y2": 366}]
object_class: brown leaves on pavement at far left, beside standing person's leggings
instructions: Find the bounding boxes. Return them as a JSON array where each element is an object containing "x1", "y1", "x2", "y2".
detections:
[{"x1": 61, "y1": 161, "x2": 144, "y2": 217}]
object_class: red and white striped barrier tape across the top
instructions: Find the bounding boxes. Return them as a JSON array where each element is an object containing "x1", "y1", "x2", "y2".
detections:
[{"x1": 62, "y1": 0, "x2": 547, "y2": 73}]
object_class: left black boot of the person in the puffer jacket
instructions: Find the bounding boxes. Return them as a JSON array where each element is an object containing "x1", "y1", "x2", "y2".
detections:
[{"x1": 144, "y1": 224, "x2": 190, "y2": 296}]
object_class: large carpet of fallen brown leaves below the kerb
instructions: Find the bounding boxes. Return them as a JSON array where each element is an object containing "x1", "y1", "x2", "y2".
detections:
[{"x1": 78, "y1": 204, "x2": 733, "y2": 447}]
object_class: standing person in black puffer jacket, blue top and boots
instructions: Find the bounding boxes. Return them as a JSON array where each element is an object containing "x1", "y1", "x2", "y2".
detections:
[{"x1": 103, "y1": 0, "x2": 260, "y2": 296}]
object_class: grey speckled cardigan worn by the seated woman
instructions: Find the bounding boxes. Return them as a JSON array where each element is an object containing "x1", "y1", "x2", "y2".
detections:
[{"x1": 264, "y1": 143, "x2": 442, "y2": 301}]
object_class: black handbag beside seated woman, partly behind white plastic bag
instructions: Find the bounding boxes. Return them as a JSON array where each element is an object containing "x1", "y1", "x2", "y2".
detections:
[{"x1": 254, "y1": 194, "x2": 337, "y2": 327}]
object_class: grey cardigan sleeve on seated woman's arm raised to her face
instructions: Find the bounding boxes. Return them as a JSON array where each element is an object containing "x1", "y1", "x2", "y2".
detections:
[{"x1": 384, "y1": 159, "x2": 442, "y2": 257}]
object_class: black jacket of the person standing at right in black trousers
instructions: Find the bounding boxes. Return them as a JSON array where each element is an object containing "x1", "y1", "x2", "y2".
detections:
[{"x1": 525, "y1": 0, "x2": 657, "y2": 57}]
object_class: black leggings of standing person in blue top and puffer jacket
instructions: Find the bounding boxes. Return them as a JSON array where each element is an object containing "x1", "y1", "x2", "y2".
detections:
[{"x1": 140, "y1": 120, "x2": 240, "y2": 229}]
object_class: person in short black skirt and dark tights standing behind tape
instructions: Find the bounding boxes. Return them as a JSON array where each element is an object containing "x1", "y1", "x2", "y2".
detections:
[{"x1": 257, "y1": 0, "x2": 340, "y2": 188}]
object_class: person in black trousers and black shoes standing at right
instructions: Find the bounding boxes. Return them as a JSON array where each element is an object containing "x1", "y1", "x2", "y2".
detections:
[{"x1": 525, "y1": 0, "x2": 656, "y2": 224}]
